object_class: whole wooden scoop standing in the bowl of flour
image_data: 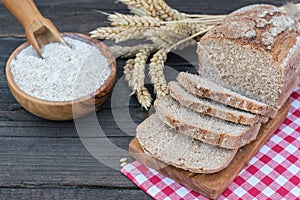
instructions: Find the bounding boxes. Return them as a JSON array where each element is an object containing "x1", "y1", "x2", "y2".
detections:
[{"x1": 2, "y1": 0, "x2": 66, "y2": 57}]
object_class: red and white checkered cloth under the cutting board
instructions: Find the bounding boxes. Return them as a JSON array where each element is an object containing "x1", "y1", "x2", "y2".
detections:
[{"x1": 121, "y1": 86, "x2": 300, "y2": 200}]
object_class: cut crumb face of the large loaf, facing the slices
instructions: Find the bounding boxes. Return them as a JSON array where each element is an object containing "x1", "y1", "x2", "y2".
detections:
[{"x1": 199, "y1": 39, "x2": 281, "y2": 107}]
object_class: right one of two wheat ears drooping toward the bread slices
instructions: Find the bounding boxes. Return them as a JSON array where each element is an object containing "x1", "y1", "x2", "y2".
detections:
[{"x1": 149, "y1": 50, "x2": 167, "y2": 98}]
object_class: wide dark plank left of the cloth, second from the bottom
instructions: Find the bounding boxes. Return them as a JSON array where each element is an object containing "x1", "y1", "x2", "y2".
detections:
[{"x1": 0, "y1": 137, "x2": 136, "y2": 188}]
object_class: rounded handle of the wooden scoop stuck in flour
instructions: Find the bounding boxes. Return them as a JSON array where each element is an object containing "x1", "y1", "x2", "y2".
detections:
[{"x1": 2, "y1": 0, "x2": 45, "y2": 32}]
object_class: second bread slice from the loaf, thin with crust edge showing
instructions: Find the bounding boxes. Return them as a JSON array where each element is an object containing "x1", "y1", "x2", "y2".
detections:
[{"x1": 168, "y1": 81, "x2": 268, "y2": 125}]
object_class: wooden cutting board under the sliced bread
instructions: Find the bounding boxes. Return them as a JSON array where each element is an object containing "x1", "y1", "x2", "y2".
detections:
[{"x1": 129, "y1": 100, "x2": 290, "y2": 199}]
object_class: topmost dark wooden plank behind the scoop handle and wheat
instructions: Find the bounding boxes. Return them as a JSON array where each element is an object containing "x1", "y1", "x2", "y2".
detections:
[{"x1": 0, "y1": 0, "x2": 128, "y2": 37}]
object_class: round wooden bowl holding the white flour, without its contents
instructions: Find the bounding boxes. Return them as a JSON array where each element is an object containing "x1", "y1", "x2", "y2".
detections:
[{"x1": 6, "y1": 33, "x2": 117, "y2": 121}]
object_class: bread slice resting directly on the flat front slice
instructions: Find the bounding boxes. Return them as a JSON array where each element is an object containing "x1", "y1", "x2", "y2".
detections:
[{"x1": 154, "y1": 96, "x2": 261, "y2": 149}]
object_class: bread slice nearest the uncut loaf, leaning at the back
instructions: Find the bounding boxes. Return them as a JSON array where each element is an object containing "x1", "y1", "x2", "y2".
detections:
[{"x1": 177, "y1": 72, "x2": 277, "y2": 118}]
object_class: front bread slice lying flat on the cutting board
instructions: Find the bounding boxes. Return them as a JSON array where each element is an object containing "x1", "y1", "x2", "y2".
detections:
[{"x1": 137, "y1": 114, "x2": 237, "y2": 173}]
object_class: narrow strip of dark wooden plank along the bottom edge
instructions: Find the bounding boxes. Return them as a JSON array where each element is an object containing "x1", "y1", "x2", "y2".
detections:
[{"x1": 0, "y1": 188, "x2": 151, "y2": 200}]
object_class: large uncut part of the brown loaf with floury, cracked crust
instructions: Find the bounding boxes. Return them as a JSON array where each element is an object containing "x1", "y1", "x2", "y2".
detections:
[{"x1": 198, "y1": 5, "x2": 300, "y2": 109}]
